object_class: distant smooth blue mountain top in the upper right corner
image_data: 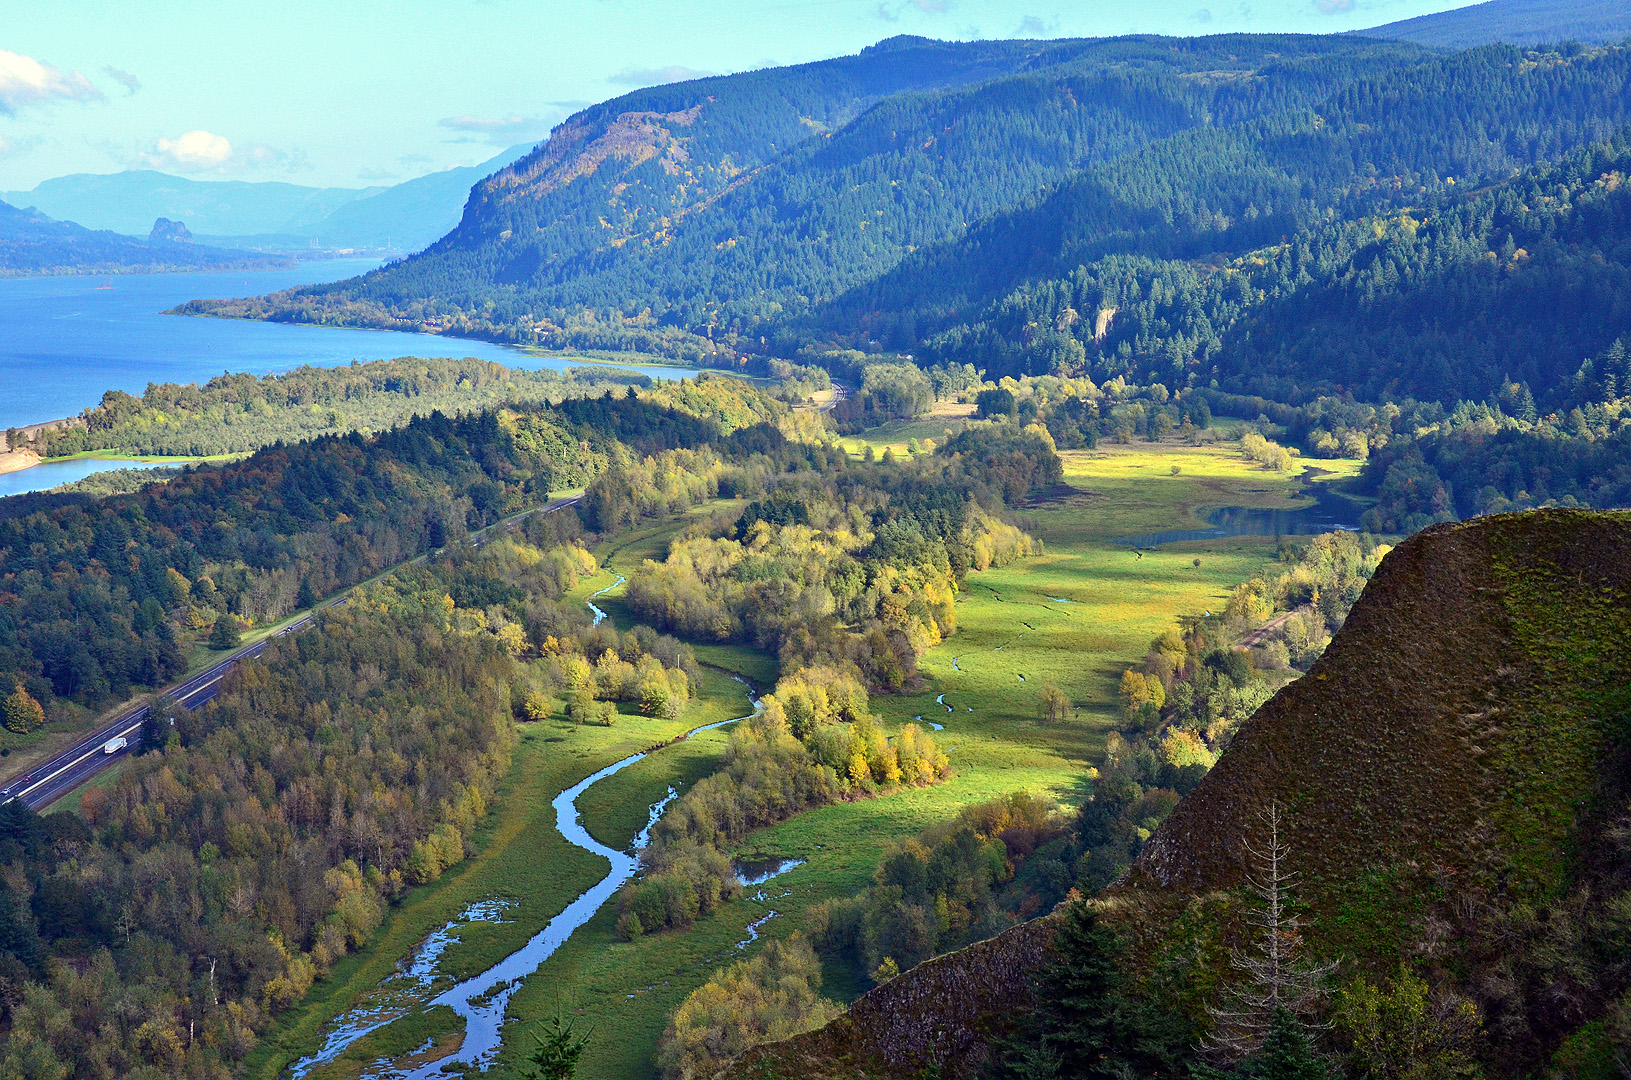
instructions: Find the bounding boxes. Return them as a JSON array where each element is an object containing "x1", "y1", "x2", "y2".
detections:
[{"x1": 1355, "y1": 0, "x2": 1631, "y2": 49}]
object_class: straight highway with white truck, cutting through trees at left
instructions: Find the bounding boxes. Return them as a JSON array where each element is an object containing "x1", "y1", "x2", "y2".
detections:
[{"x1": 0, "y1": 494, "x2": 584, "y2": 811}]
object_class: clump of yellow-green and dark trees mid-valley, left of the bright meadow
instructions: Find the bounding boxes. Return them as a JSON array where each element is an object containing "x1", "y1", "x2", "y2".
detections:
[{"x1": 616, "y1": 431, "x2": 1060, "y2": 688}]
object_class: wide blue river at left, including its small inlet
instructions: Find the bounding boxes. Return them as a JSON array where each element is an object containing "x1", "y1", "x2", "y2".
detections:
[{"x1": 0, "y1": 259, "x2": 695, "y2": 494}]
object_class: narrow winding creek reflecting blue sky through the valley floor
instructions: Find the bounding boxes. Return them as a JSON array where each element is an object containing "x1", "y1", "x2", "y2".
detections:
[{"x1": 285, "y1": 574, "x2": 756, "y2": 1080}]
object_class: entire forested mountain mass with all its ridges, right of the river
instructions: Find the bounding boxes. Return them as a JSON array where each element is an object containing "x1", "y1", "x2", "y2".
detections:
[{"x1": 189, "y1": 36, "x2": 1631, "y2": 408}]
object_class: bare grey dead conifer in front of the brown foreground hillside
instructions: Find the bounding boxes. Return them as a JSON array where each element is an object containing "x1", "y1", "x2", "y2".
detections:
[{"x1": 1202, "y1": 803, "x2": 1336, "y2": 1064}]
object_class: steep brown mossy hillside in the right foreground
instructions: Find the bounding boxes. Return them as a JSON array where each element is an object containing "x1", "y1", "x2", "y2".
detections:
[{"x1": 727, "y1": 511, "x2": 1631, "y2": 1080}]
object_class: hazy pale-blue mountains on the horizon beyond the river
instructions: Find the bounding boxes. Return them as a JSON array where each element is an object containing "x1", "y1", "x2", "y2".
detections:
[{"x1": 0, "y1": 145, "x2": 532, "y2": 251}]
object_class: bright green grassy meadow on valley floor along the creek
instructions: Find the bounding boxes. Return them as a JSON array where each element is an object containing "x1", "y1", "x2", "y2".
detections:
[{"x1": 256, "y1": 432, "x2": 1355, "y2": 1080}]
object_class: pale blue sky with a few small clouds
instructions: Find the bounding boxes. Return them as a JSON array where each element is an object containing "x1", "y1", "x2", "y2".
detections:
[{"x1": 0, "y1": 0, "x2": 1463, "y2": 191}]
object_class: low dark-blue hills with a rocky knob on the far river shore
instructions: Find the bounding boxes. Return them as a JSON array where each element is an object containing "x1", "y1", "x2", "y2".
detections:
[{"x1": 0, "y1": 202, "x2": 292, "y2": 277}]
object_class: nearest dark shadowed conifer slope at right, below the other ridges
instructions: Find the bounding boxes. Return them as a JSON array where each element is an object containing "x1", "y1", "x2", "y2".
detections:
[{"x1": 926, "y1": 115, "x2": 1631, "y2": 411}]
